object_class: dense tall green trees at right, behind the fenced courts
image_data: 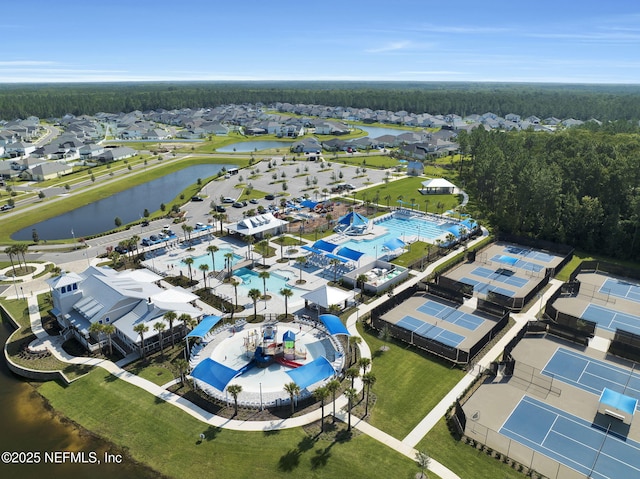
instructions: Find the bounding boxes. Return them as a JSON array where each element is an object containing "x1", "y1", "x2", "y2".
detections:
[{"x1": 458, "y1": 128, "x2": 640, "y2": 260}]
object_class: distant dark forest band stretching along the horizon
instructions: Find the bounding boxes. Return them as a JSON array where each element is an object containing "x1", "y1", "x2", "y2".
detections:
[{"x1": 0, "y1": 82, "x2": 640, "y2": 121}]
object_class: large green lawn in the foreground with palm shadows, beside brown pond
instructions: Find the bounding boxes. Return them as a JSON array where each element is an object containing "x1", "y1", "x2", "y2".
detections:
[{"x1": 39, "y1": 370, "x2": 418, "y2": 479}]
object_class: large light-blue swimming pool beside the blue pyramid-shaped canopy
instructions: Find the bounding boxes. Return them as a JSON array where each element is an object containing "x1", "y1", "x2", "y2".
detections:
[{"x1": 340, "y1": 215, "x2": 462, "y2": 257}]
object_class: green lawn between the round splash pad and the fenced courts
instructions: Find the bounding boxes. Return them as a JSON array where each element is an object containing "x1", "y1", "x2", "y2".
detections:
[{"x1": 359, "y1": 326, "x2": 464, "y2": 439}]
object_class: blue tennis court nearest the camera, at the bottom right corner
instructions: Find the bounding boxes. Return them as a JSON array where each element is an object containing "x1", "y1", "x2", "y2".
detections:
[{"x1": 500, "y1": 396, "x2": 640, "y2": 479}]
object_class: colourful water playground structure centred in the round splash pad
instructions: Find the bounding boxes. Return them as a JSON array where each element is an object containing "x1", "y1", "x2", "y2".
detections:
[{"x1": 244, "y1": 323, "x2": 307, "y2": 368}]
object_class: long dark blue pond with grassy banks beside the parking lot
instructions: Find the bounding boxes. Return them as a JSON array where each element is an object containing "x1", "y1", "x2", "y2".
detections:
[{"x1": 11, "y1": 165, "x2": 233, "y2": 241}]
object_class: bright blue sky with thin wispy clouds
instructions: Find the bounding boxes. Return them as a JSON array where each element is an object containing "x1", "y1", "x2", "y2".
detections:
[{"x1": 0, "y1": 0, "x2": 640, "y2": 83}]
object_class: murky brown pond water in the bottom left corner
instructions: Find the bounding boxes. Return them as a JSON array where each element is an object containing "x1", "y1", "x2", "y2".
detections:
[{"x1": 0, "y1": 322, "x2": 157, "y2": 479}]
